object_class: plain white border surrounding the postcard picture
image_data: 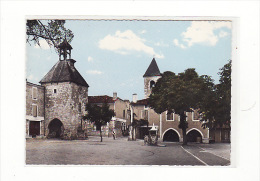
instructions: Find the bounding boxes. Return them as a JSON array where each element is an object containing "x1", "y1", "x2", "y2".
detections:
[{"x1": 0, "y1": 0, "x2": 259, "y2": 181}]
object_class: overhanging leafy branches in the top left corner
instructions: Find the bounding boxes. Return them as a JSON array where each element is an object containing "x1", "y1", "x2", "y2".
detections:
[{"x1": 26, "y1": 20, "x2": 74, "y2": 51}]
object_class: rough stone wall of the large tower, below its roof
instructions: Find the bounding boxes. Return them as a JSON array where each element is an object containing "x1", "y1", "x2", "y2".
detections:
[{"x1": 43, "y1": 82, "x2": 88, "y2": 139}]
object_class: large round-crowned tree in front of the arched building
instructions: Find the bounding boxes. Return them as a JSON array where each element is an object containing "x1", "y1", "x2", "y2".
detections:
[{"x1": 149, "y1": 69, "x2": 211, "y2": 145}]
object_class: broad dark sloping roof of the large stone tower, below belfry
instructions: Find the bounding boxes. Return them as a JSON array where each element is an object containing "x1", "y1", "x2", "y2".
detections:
[{"x1": 40, "y1": 59, "x2": 89, "y2": 87}]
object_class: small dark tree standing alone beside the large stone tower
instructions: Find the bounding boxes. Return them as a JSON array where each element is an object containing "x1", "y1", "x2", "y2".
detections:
[{"x1": 83, "y1": 103, "x2": 115, "y2": 142}]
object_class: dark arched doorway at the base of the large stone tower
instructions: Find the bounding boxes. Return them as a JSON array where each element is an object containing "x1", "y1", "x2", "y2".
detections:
[{"x1": 48, "y1": 119, "x2": 64, "y2": 138}]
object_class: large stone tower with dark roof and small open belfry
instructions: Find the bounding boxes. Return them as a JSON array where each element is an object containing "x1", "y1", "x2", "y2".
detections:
[{"x1": 40, "y1": 39, "x2": 89, "y2": 139}]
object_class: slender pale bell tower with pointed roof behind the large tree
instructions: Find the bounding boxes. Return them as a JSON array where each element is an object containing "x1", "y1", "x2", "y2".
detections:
[{"x1": 143, "y1": 58, "x2": 161, "y2": 99}]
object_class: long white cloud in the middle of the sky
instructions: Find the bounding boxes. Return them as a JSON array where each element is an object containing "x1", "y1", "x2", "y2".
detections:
[{"x1": 99, "y1": 30, "x2": 164, "y2": 58}]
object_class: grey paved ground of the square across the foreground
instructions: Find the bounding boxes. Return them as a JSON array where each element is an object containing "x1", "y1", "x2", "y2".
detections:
[{"x1": 26, "y1": 137, "x2": 230, "y2": 165}]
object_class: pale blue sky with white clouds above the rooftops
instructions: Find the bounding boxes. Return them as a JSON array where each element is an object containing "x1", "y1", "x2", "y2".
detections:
[{"x1": 26, "y1": 20, "x2": 232, "y2": 100}]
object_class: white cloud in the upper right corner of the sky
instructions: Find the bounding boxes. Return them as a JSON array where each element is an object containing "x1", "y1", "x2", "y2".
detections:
[{"x1": 173, "y1": 21, "x2": 231, "y2": 48}]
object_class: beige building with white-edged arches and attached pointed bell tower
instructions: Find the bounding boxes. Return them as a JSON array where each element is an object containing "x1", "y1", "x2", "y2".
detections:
[{"x1": 131, "y1": 58, "x2": 210, "y2": 143}]
